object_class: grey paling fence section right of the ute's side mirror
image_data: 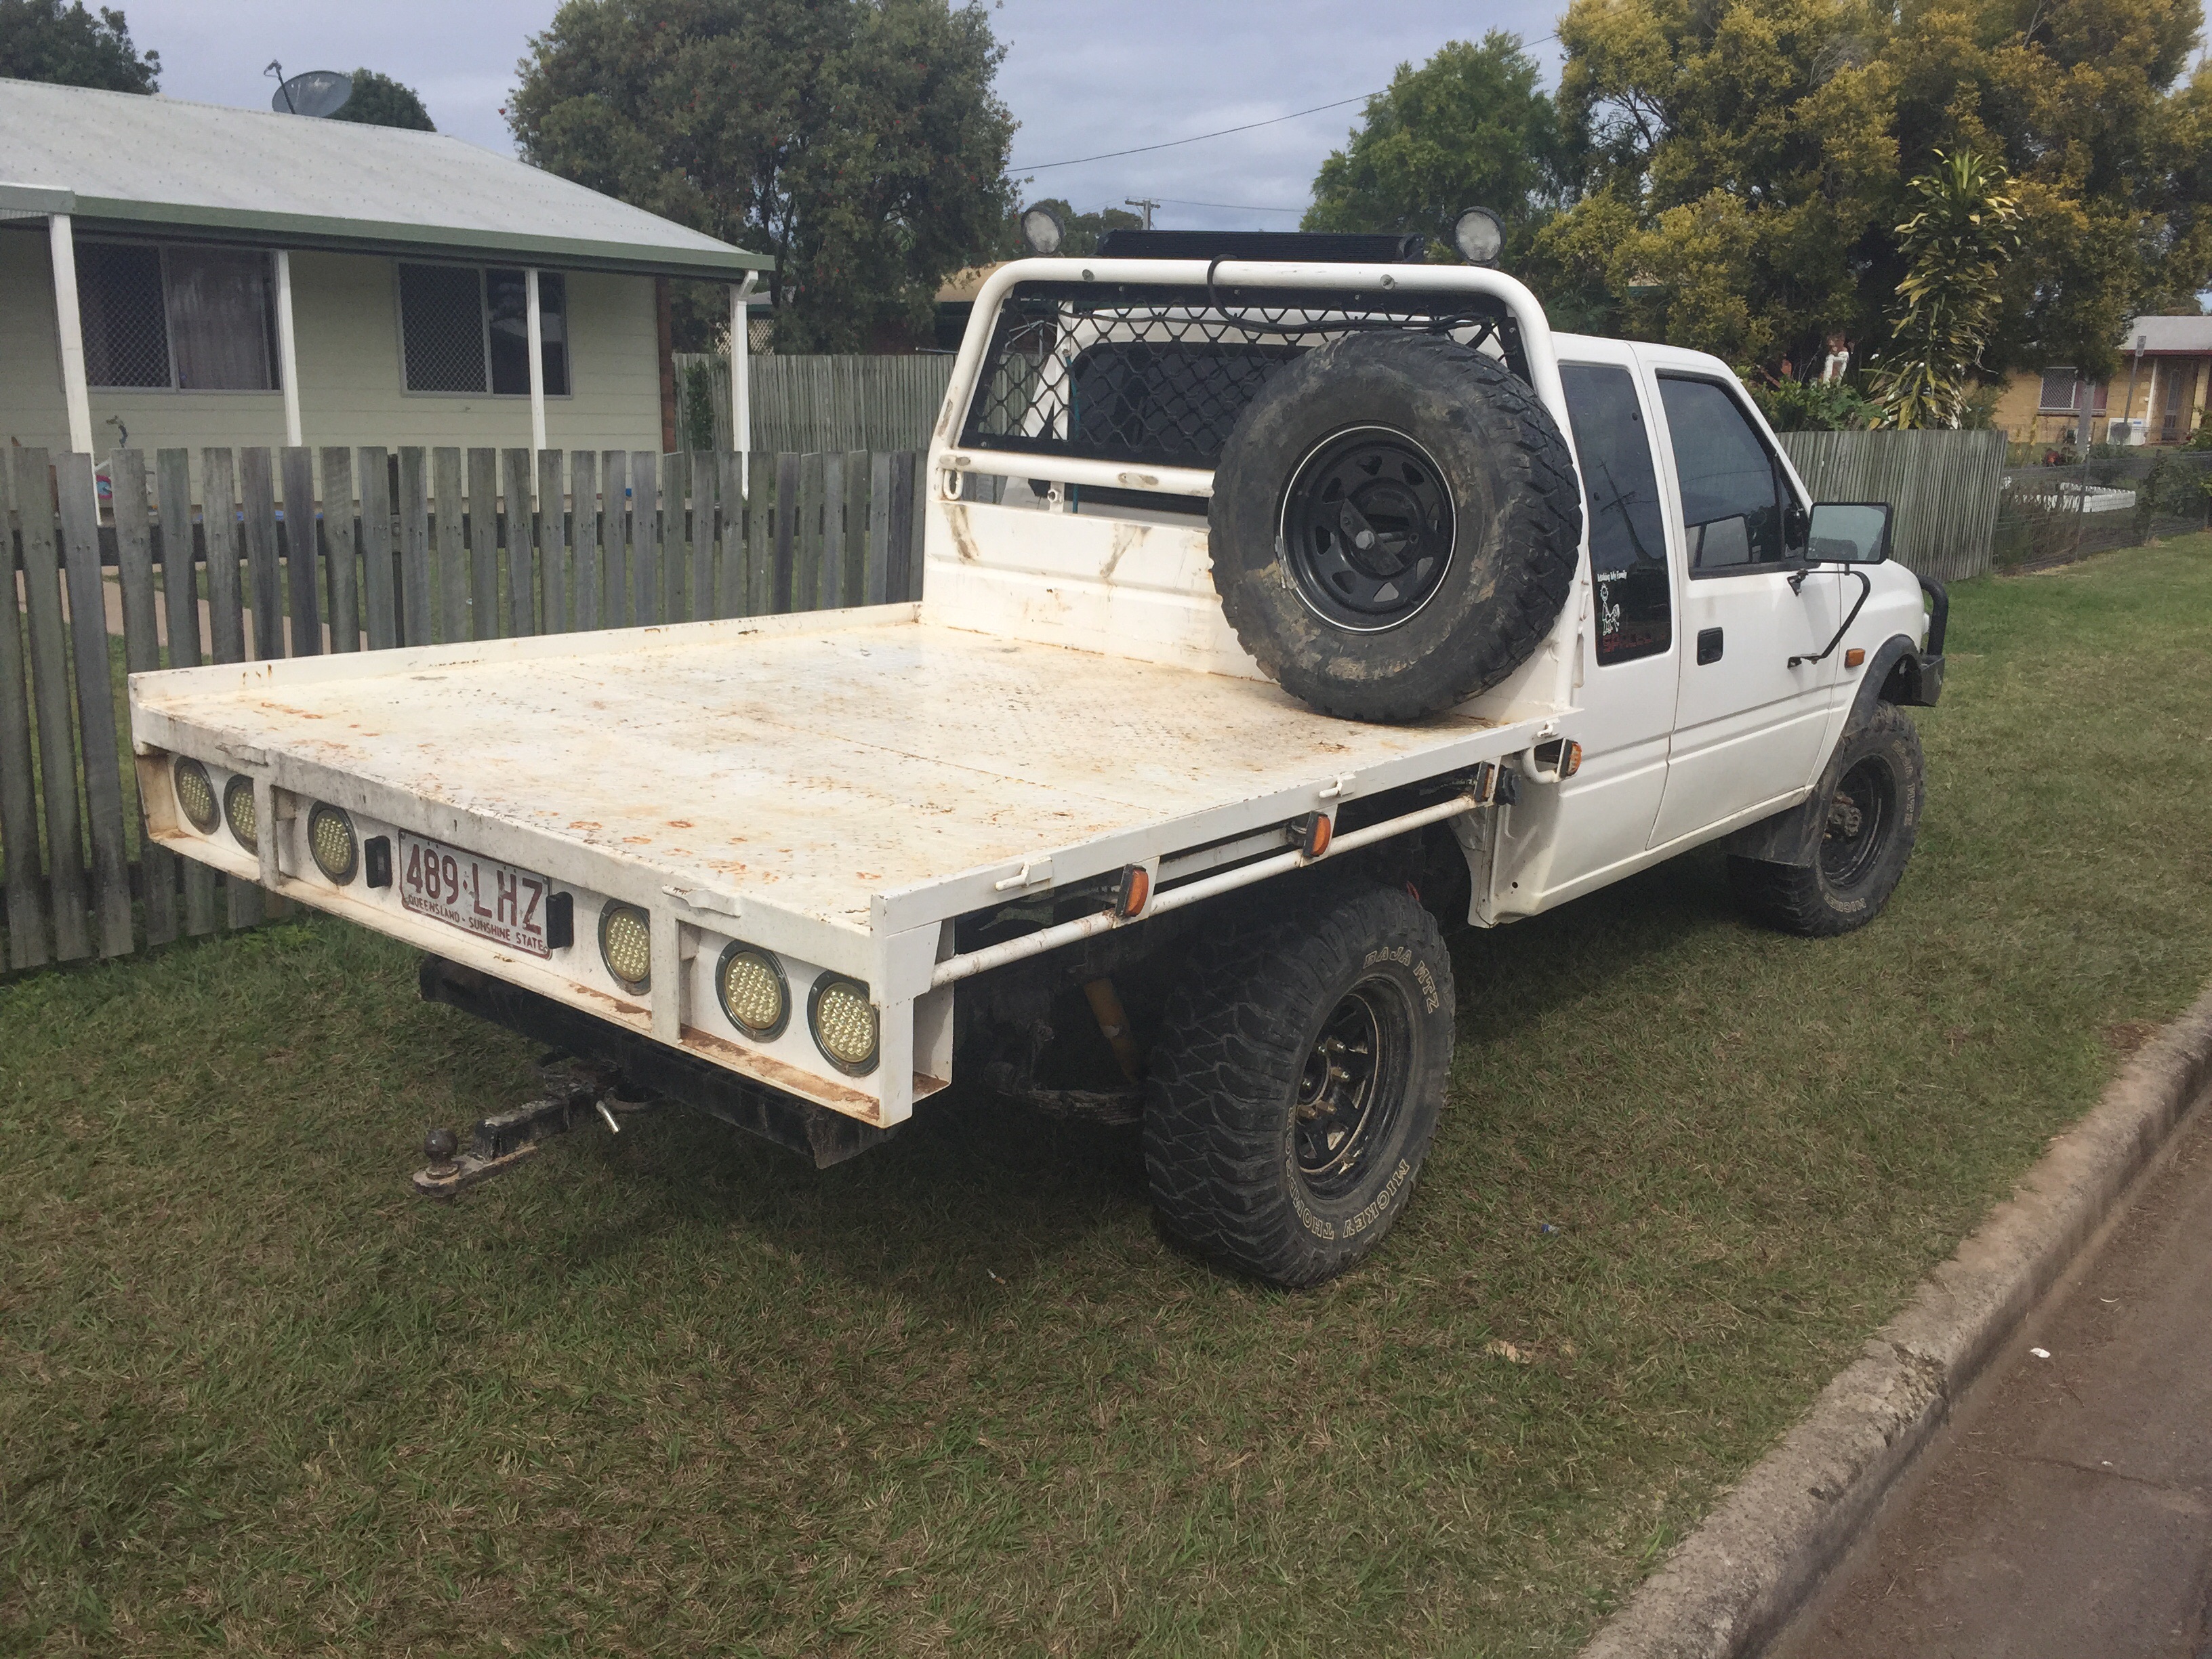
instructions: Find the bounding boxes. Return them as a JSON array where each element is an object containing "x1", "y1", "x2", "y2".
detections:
[{"x1": 1778, "y1": 431, "x2": 2004, "y2": 581}]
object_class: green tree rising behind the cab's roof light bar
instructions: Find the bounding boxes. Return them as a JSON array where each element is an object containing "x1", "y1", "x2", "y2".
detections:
[{"x1": 1303, "y1": 28, "x2": 1575, "y2": 261}]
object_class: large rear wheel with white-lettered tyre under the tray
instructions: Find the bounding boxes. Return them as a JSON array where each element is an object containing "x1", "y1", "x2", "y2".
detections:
[{"x1": 1143, "y1": 885, "x2": 1453, "y2": 1285}]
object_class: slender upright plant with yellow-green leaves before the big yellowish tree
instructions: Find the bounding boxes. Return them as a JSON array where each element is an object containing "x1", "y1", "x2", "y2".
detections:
[{"x1": 1874, "y1": 150, "x2": 2020, "y2": 427}]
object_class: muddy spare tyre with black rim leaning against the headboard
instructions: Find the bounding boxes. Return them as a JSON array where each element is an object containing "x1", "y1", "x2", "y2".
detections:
[{"x1": 1208, "y1": 332, "x2": 1582, "y2": 721}]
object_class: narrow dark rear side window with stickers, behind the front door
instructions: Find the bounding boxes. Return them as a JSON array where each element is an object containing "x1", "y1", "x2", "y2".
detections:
[{"x1": 1559, "y1": 363, "x2": 1675, "y2": 663}]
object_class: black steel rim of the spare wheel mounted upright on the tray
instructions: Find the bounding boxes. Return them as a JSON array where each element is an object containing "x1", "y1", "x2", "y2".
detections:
[{"x1": 1281, "y1": 427, "x2": 1458, "y2": 633}]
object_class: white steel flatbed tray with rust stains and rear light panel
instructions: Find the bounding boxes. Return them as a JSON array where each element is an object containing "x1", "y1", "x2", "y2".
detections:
[{"x1": 131, "y1": 604, "x2": 1540, "y2": 1122}]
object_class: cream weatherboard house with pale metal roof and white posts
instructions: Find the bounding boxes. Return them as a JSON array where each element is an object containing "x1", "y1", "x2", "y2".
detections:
[{"x1": 0, "y1": 80, "x2": 770, "y2": 451}]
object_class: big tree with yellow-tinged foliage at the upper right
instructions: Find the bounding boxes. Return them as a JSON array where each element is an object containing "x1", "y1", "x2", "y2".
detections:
[{"x1": 1535, "y1": 0, "x2": 2212, "y2": 374}]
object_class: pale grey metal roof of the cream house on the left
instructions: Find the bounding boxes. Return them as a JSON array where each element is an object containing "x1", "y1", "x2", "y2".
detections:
[{"x1": 0, "y1": 80, "x2": 774, "y2": 281}]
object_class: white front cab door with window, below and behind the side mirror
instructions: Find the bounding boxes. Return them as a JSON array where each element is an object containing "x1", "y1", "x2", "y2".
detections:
[{"x1": 1650, "y1": 369, "x2": 1843, "y2": 847}]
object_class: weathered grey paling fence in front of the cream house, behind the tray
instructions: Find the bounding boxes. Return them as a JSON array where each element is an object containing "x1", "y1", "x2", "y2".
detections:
[{"x1": 0, "y1": 449, "x2": 922, "y2": 971}]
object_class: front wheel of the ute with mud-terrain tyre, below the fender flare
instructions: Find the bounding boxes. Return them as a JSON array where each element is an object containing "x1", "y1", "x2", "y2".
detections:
[{"x1": 1727, "y1": 703, "x2": 1927, "y2": 938}]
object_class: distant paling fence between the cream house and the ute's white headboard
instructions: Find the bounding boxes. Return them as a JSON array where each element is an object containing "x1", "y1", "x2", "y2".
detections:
[{"x1": 675, "y1": 352, "x2": 954, "y2": 451}]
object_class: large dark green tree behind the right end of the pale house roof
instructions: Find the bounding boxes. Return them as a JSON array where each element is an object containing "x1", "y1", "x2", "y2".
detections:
[{"x1": 509, "y1": 0, "x2": 1013, "y2": 352}]
